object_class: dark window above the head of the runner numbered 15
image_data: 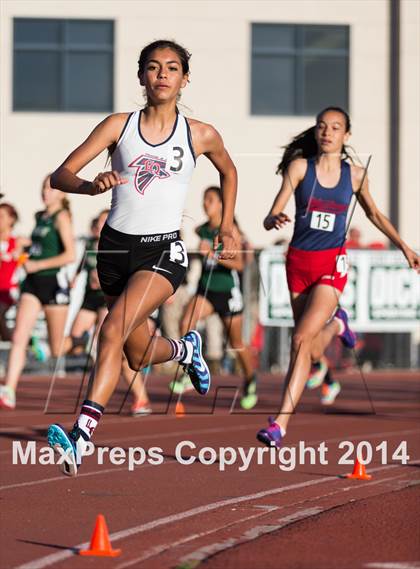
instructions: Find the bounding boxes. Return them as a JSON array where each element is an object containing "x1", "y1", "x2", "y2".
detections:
[{"x1": 251, "y1": 24, "x2": 349, "y2": 115}]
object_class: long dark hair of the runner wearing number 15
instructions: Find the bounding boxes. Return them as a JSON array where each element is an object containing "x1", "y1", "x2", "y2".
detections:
[{"x1": 276, "y1": 107, "x2": 353, "y2": 175}]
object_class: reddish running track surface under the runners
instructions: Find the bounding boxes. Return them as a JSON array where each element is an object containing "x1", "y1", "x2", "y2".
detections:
[{"x1": 0, "y1": 373, "x2": 420, "y2": 569}]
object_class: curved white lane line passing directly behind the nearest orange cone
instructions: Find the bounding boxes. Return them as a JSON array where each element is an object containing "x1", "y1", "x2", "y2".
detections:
[{"x1": 12, "y1": 460, "x2": 420, "y2": 569}]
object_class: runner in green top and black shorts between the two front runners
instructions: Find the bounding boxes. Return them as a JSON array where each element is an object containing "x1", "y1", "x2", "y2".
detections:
[{"x1": 169, "y1": 186, "x2": 258, "y2": 409}]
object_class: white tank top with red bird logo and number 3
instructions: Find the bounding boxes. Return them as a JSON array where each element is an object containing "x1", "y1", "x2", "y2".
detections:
[{"x1": 107, "y1": 111, "x2": 195, "y2": 235}]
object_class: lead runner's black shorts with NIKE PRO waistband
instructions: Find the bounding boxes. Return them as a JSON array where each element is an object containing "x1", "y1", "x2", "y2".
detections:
[{"x1": 97, "y1": 224, "x2": 188, "y2": 296}]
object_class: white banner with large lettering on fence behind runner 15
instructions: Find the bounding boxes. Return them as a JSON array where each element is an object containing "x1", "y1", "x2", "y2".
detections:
[{"x1": 259, "y1": 247, "x2": 420, "y2": 332}]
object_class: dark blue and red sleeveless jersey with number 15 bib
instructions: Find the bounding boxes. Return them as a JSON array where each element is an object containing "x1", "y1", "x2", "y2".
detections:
[{"x1": 290, "y1": 158, "x2": 353, "y2": 251}]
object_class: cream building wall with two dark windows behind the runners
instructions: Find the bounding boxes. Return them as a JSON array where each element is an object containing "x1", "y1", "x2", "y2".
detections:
[{"x1": 0, "y1": 0, "x2": 420, "y2": 246}]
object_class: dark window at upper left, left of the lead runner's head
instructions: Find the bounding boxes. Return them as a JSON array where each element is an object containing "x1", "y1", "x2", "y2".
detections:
[{"x1": 13, "y1": 18, "x2": 114, "y2": 112}]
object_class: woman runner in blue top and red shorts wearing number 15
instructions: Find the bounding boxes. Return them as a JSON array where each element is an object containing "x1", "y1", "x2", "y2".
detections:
[{"x1": 257, "y1": 107, "x2": 420, "y2": 447}]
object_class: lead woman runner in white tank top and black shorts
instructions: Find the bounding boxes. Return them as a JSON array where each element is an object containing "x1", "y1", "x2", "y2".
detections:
[{"x1": 48, "y1": 40, "x2": 238, "y2": 475}]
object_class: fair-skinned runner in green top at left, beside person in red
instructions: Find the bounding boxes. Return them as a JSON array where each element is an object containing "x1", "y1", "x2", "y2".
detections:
[{"x1": 0, "y1": 175, "x2": 75, "y2": 409}]
